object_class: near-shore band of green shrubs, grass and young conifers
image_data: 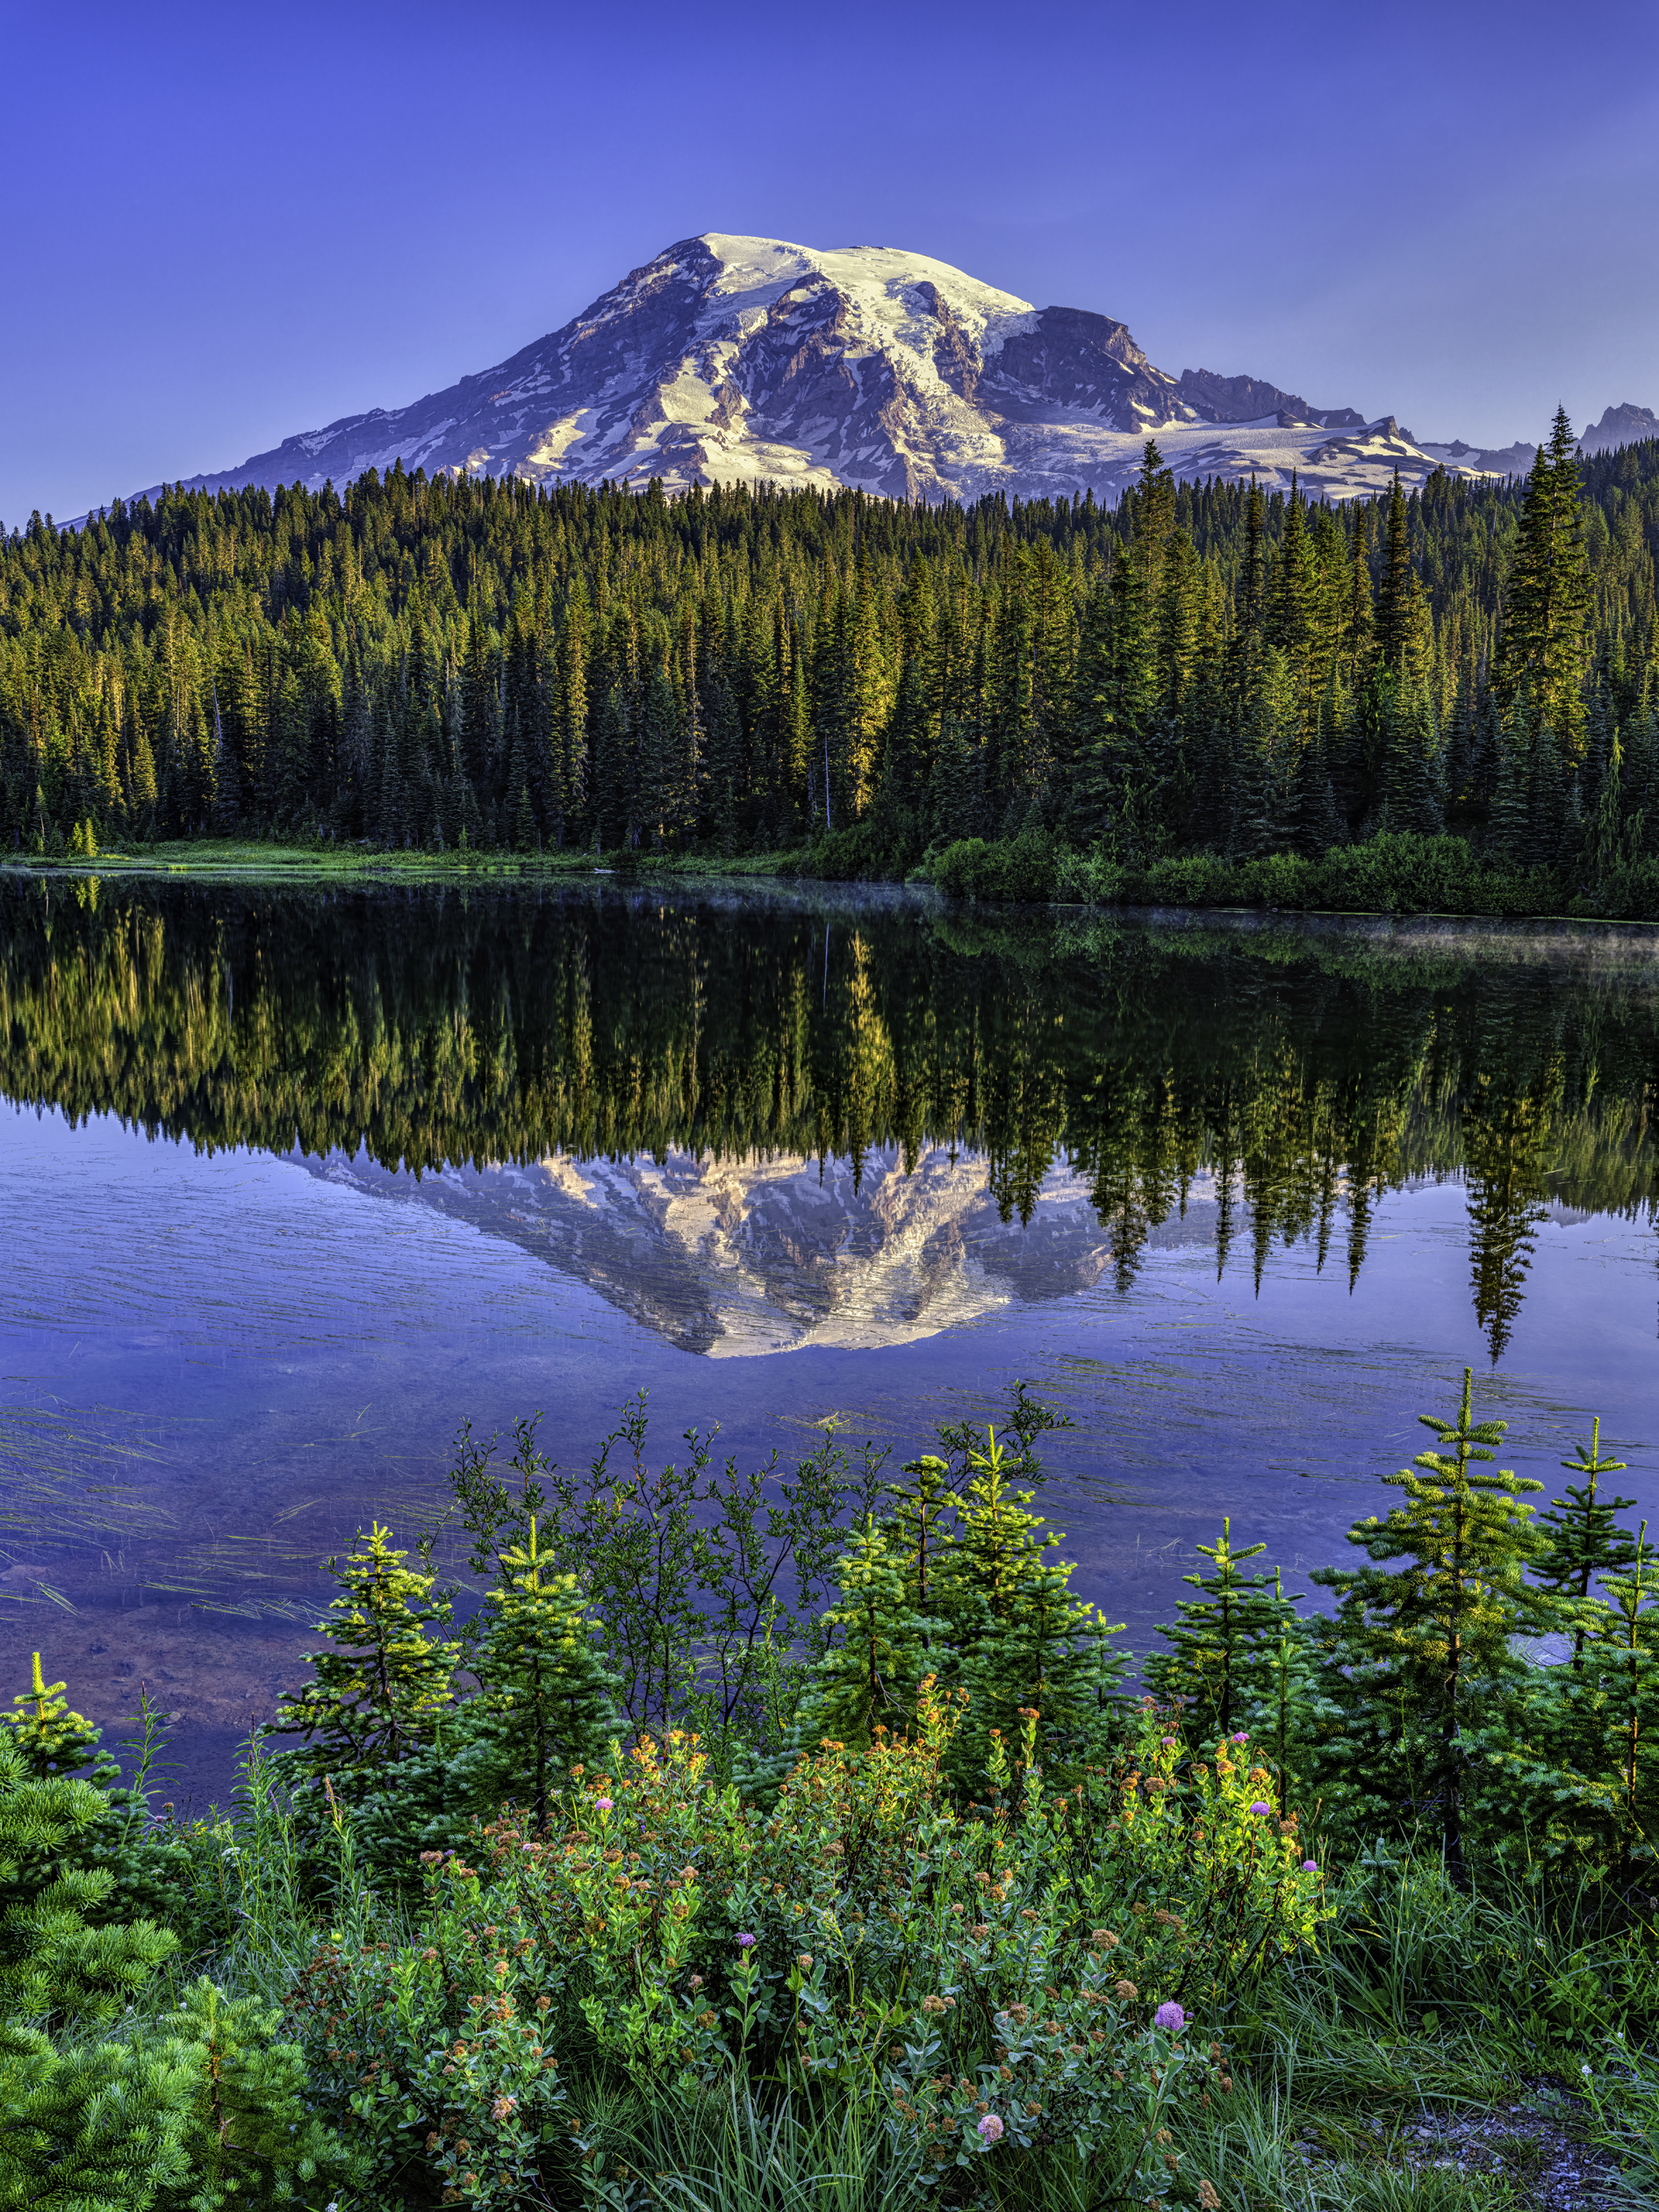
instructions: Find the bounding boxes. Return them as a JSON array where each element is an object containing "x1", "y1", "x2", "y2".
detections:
[{"x1": 0, "y1": 1378, "x2": 1659, "y2": 2212}]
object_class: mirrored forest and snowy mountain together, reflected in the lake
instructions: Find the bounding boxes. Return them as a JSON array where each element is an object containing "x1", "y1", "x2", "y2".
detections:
[{"x1": 0, "y1": 876, "x2": 1659, "y2": 1361}]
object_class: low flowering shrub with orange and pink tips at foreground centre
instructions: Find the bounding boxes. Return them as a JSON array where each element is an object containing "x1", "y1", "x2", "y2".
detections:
[{"x1": 285, "y1": 1684, "x2": 1327, "y2": 2205}]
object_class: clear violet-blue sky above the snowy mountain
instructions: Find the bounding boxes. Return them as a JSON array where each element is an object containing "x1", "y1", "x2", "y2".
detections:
[{"x1": 0, "y1": 0, "x2": 1659, "y2": 524}]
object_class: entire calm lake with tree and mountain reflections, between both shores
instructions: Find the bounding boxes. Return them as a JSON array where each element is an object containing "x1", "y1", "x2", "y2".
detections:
[{"x1": 0, "y1": 873, "x2": 1659, "y2": 1803}]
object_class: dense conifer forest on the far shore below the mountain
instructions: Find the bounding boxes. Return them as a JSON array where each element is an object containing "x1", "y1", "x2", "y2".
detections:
[{"x1": 0, "y1": 416, "x2": 1659, "y2": 880}]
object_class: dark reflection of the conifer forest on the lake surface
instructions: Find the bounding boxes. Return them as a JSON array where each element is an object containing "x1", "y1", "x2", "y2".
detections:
[{"x1": 0, "y1": 878, "x2": 1659, "y2": 1356}]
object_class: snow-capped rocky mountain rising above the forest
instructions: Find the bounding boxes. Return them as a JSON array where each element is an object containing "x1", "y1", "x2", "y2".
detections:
[{"x1": 133, "y1": 233, "x2": 1659, "y2": 500}]
